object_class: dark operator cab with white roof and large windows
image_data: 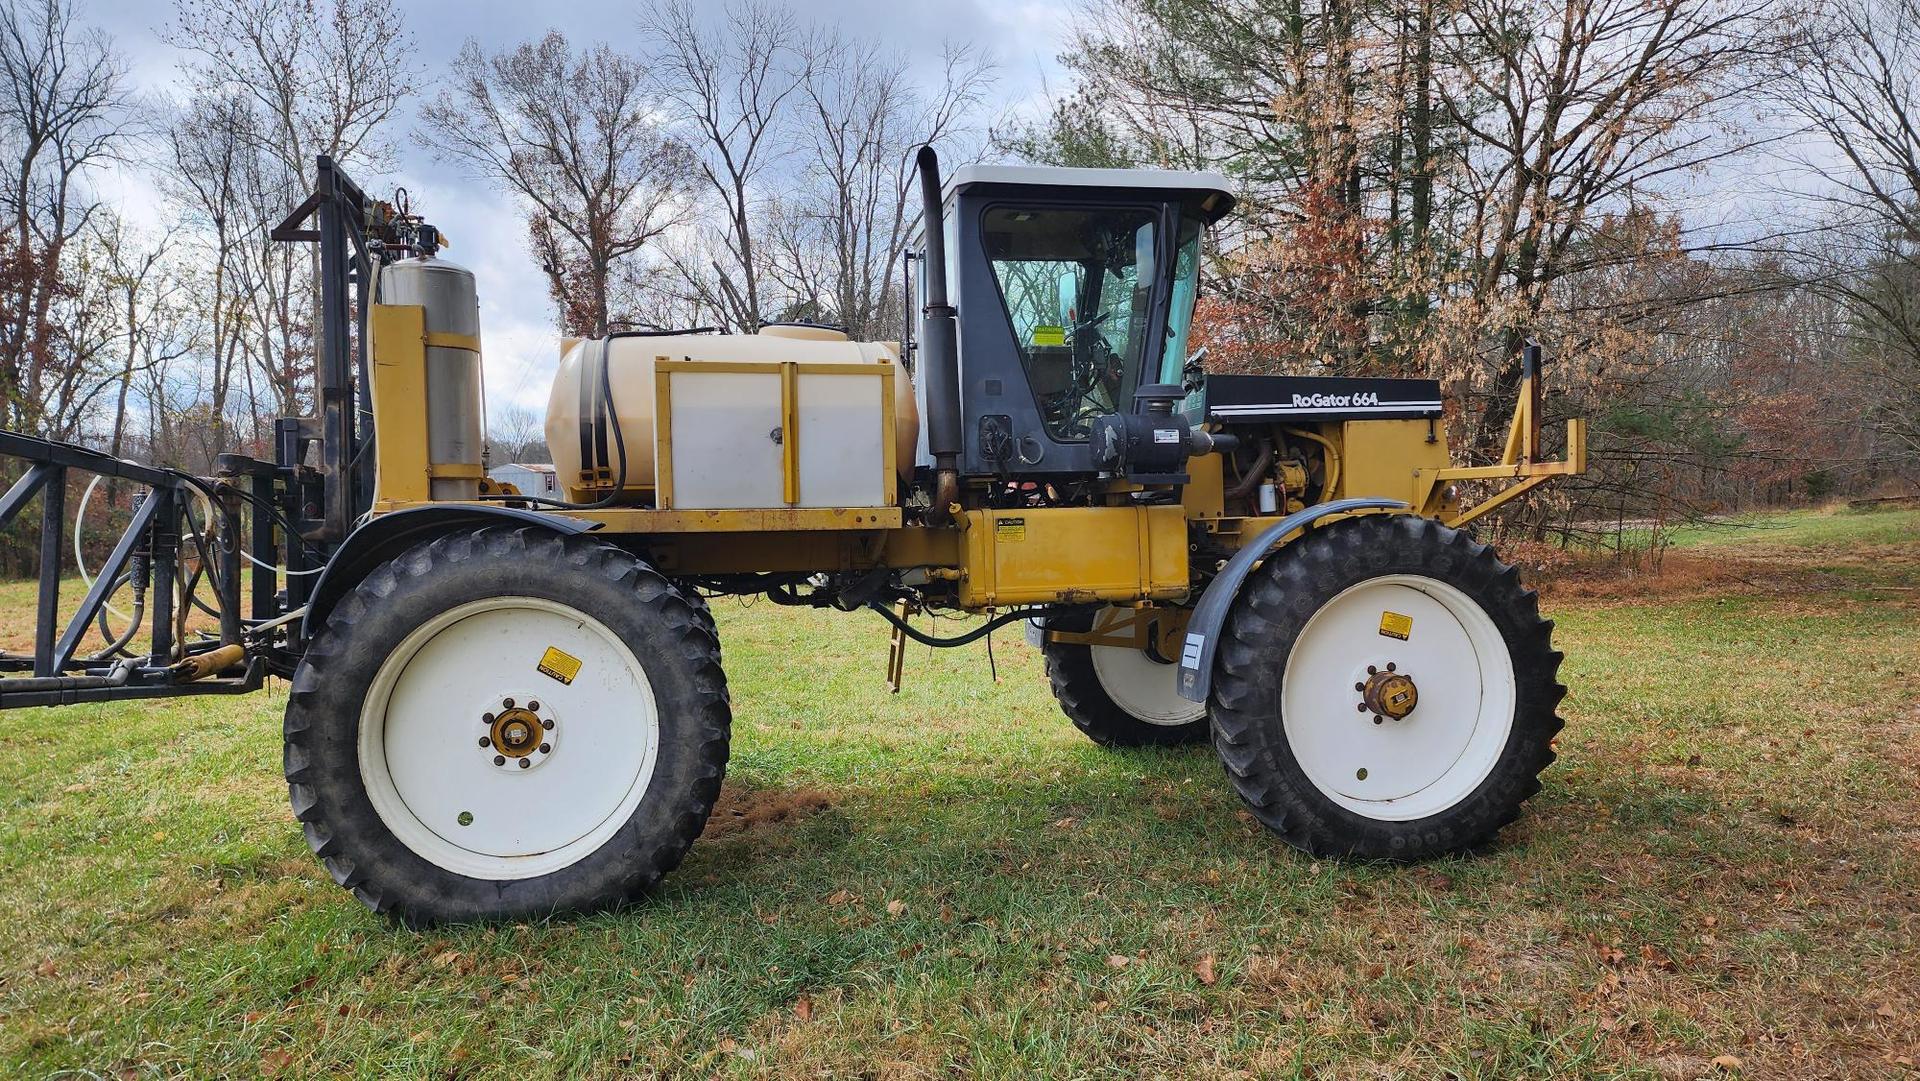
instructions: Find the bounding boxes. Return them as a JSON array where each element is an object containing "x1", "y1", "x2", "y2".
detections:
[{"x1": 914, "y1": 165, "x2": 1233, "y2": 476}]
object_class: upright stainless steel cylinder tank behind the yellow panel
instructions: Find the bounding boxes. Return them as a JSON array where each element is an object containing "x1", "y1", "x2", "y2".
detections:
[{"x1": 380, "y1": 259, "x2": 486, "y2": 499}]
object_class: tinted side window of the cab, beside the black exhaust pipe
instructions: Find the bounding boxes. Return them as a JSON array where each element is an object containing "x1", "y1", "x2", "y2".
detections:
[{"x1": 983, "y1": 207, "x2": 1152, "y2": 444}]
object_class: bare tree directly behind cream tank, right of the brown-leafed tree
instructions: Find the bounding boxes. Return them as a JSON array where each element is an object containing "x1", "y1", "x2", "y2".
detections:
[{"x1": 639, "y1": 0, "x2": 808, "y2": 332}]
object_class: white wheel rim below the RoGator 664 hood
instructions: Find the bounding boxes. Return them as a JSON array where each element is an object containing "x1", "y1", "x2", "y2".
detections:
[{"x1": 1281, "y1": 574, "x2": 1515, "y2": 822}]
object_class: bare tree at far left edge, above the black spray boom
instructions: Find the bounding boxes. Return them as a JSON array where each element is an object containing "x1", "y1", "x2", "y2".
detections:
[{"x1": 0, "y1": 0, "x2": 132, "y2": 430}]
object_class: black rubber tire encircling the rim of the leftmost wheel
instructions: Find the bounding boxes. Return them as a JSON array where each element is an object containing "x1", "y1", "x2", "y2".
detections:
[{"x1": 282, "y1": 526, "x2": 732, "y2": 927}]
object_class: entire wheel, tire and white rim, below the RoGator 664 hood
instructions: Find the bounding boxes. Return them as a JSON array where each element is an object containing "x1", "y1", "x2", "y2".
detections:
[{"x1": 1210, "y1": 515, "x2": 1567, "y2": 860}]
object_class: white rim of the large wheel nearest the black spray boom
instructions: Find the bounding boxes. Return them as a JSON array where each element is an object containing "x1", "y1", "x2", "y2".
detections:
[{"x1": 359, "y1": 597, "x2": 660, "y2": 879}]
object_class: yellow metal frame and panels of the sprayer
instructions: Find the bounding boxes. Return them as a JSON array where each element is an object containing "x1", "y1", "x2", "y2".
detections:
[{"x1": 369, "y1": 305, "x2": 1586, "y2": 614}]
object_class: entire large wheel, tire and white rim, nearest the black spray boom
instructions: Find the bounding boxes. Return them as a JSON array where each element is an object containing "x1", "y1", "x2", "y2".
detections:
[{"x1": 286, "y1": 526, "x2": 732, "y2": 925}]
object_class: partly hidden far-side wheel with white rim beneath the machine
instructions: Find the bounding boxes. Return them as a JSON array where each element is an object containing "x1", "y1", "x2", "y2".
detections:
[{"x1": 1044, "y1": 609, "x2": 1208, "y2": 747}]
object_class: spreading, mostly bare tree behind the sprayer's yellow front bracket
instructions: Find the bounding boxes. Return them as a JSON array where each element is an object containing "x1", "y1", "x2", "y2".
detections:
[{"x1": 1438, "y1": 0, "x2": 1778, "y2": 451}]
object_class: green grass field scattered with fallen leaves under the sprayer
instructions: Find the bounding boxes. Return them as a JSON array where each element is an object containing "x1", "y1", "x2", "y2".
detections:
[{"x1": 0, "y1": 511, "x2": 1920, "y2": 1079}]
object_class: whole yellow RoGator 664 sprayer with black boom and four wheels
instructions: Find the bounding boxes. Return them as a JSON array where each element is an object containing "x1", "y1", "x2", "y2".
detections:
[{"x1": 0, "y1": 150, "x2": 1584, "y2": 922}]
